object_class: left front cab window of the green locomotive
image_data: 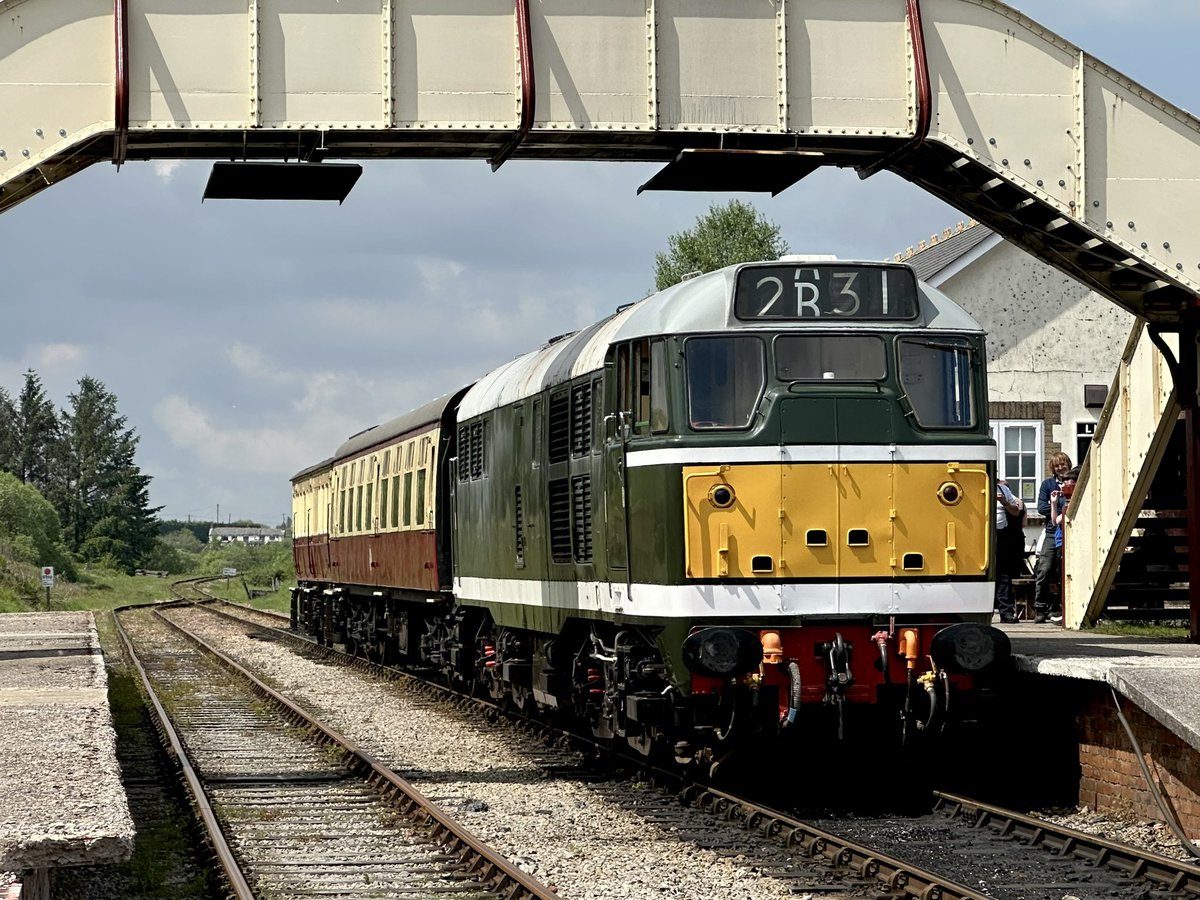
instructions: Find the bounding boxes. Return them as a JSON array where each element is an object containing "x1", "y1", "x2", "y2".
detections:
[{"x1": 684, "y1": 336, "x2": 767, "y2": 430}]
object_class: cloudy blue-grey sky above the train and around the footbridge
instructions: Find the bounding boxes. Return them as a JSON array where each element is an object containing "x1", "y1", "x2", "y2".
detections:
[{"x1": 0, "y1": 0, "x2": 1200, "y2": 526}]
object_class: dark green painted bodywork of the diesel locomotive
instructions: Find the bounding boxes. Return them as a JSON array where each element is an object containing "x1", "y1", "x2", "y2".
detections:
[{"x1": 454, "y1": 336, "x2": 991, "y2": 640}]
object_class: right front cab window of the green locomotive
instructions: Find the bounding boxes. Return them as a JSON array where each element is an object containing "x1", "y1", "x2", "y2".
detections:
[{"x1": 896, "y1": 337, "x2": 976, "y2": 428}]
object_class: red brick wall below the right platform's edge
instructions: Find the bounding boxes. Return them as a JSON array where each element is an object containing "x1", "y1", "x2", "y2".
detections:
[{"x1": 1078, "y1": 684, "x2": 1200, "y2": 835}]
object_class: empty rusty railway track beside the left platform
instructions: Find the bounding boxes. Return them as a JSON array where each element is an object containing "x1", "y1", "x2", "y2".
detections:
[{"x1": 110, "y1": 610, "x2": 554, "y2": 900}]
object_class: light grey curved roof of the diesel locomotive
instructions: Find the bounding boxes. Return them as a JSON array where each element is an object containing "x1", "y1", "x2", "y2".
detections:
[{"x1": 453, "y1": 257, "x2": 983, "y2": 420}]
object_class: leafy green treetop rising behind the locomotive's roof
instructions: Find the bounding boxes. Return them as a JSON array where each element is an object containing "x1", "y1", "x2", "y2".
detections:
[{"x1": 654, "y1": 200, "x2": 787, "y2": 290}]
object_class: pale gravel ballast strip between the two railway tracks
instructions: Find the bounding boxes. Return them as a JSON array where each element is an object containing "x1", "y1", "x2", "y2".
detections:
[{"x1": 172, "y1": 611, "x2": 816, "y2": 900}]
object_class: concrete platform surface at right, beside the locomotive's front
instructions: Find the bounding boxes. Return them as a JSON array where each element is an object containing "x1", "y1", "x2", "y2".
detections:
[{"x1": 1001, "y1": 623, "x2": 1200, "y2": 750}]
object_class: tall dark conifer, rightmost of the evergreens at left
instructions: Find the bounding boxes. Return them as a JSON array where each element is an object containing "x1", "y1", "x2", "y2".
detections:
[{"x1": 60, "y1": 376, "x2": 161, "y2": 571}]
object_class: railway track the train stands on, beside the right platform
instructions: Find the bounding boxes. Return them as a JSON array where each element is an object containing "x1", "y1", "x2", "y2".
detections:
[{"x1": 189, "y1": 605, "x2": 1200, "y2": 900}]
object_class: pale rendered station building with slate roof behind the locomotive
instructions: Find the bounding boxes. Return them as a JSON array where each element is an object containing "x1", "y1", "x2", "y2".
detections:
[{"x1": 895, "y1": 221, "x2": 1134, "y2": 510}]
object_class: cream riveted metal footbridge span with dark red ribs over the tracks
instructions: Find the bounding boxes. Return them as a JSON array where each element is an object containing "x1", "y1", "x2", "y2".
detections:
[{"x1": 7, "y1": 0, "x2": 1200, "y2": 637}]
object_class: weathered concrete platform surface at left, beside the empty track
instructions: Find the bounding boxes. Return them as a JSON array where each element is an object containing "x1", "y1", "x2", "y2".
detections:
[{"x1": 0, "y1": 612, "x2": 133, "y2": 872}]
